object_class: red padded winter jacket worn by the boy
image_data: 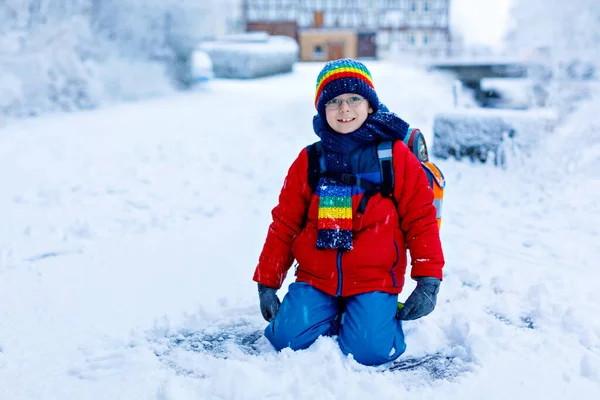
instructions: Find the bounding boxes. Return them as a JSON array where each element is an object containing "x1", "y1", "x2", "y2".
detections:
[{"x1": 254, "y1": 141, "x2": 444, "y2": 296}]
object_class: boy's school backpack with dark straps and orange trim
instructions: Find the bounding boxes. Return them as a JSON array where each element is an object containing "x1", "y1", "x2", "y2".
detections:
[{"x1": 306, "y1": 128, "x2": 446, "y2": 228}]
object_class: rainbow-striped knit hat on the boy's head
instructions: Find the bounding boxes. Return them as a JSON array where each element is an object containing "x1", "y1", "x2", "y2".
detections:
[{"x1": 315, "y1": 58, "x2": 379, "y2": 118}]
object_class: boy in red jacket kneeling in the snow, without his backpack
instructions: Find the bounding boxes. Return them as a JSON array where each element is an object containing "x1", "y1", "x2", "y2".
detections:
[{"x1": 254, "y1": 59, "x2": 444, "y2": 365}]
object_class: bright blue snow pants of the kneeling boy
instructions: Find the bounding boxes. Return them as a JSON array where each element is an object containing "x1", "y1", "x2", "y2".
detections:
[{"x1": 265, "y1": 282, "x2": 406, "y2": 365}]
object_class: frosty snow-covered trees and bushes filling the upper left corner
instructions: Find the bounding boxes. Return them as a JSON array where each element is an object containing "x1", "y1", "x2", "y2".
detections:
[{"x1": 0, "y1": 0, "x2": 221, "y2": 117}]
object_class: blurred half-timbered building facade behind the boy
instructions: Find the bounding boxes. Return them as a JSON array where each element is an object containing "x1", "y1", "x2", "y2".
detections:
[{"x1": 242, "y1": 0, "x2": 451, "y2": 58}]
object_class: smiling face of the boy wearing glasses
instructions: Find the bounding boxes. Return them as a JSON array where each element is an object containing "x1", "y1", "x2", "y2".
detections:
[{"x1": 325, "y1": 93, "x2": 373, "y2": 135}]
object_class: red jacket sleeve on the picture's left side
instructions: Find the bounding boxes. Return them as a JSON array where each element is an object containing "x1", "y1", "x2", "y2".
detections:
[{"x1": 253, "y1": 149, "x2": 312, "y2": 289}]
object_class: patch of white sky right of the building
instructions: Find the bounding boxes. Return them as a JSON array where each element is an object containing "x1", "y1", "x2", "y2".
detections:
[{"x1": 450, "y1": 0, "x2": 513, "y2": 48}]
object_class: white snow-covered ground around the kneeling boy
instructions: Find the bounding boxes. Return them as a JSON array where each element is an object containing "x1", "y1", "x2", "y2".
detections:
[{"x1": 0, "y1": 63, "x2": 600, "y2": 400}]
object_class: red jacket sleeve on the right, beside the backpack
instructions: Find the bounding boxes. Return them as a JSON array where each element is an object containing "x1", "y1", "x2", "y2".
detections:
[{"x1": 393, "y1": 141, "x2": 444, "y2": 279}]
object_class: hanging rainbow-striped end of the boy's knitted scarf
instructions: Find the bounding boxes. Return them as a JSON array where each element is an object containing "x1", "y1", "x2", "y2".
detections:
[{"x1": 317, "y1": 177, "x2": 352, "y2": 250}]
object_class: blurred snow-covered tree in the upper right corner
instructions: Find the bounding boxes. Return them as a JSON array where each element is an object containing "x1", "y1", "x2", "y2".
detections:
[{"x1": 506, "y1": 0, "x2": 600, "y2": 114}]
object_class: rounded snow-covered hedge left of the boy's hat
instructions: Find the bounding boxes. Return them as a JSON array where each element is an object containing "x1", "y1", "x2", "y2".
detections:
[{"x1": 199, "y1": 35, "x2": 298, "y2": 79}]
